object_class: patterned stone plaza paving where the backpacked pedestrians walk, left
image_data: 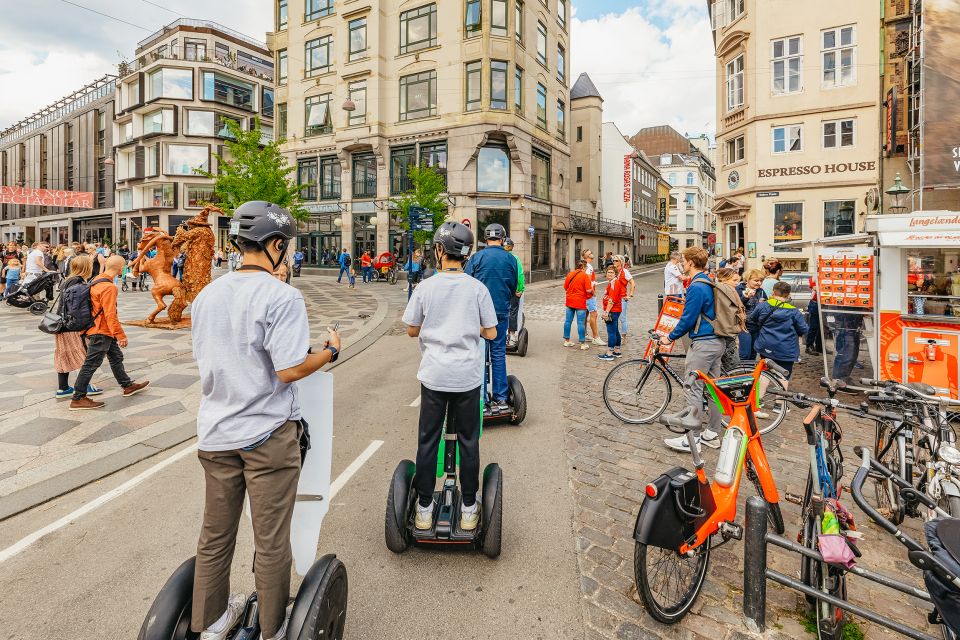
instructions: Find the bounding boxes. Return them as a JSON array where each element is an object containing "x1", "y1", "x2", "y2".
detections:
[{"x1": 0, "y1": 276, "x2": 399, "y2": 519}]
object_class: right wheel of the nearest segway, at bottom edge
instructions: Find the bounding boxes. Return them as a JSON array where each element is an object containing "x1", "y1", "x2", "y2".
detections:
[{"x1": 287, "y1": 554, "x2": 348, "y2": 640}]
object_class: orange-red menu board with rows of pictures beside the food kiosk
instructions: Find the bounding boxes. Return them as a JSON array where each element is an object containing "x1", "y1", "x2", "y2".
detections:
[{"x1": 817, "y1": 249, "x2": 877, "y2": 311}]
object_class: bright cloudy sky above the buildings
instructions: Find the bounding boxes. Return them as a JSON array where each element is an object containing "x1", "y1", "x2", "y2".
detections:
[{"x1": 0, "y1": 0, "x2": 715, "y2": 136}]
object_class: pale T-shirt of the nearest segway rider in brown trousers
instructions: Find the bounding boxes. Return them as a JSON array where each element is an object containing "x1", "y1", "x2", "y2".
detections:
[{"x1": 192, "y1": 272, "x2": 310, "y2": 451}]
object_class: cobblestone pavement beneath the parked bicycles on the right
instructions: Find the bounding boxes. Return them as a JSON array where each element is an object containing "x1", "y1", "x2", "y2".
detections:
[{"x1": 526, "y1": 275, "x2": 939, "y2": 640}]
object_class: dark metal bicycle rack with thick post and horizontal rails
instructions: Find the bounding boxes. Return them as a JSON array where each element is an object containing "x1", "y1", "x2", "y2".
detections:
[{"x1": 743, "y1": 496, "x2": 942, "y2": 640}]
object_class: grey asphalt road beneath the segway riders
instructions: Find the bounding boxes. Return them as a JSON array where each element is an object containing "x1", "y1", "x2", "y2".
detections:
[{"x1": 0, "y1": 321, "x2": 582, "y2": 640}]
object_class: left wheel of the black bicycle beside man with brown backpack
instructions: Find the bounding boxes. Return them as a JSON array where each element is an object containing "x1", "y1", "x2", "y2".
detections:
[{"x1": 603, "y1": 360, "x2": 673, "y2": 424}]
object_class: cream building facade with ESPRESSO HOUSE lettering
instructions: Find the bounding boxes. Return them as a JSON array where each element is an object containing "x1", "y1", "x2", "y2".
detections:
[{"x1": 711, "y1": 0, "x2": 880, "y2": 271}]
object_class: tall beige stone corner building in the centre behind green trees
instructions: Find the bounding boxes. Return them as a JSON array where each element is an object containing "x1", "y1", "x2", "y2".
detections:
[{"x1": 268, "y1": 0, "x2": 571, "y2": 280}]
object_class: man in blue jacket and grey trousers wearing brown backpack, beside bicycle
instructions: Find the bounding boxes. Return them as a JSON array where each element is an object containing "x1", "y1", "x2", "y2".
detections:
[{"x1": 660, "y1": 247, "x2": 725, "y2": 453}]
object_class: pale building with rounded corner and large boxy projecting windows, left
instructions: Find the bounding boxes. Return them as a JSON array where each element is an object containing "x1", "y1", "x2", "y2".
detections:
[{"x1": 113, "y1": 19, "x2": 275, "y2": 248}]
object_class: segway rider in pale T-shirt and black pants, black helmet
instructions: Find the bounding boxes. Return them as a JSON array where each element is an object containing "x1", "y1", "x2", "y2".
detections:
[{"x1": 403, "y1": 222, "x2": 497, "y2": 531}]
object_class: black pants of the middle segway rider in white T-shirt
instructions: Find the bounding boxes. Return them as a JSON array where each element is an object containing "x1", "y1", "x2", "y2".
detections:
[{"x1": 413, "y1": 385, "x2": 481, "y2": 506}]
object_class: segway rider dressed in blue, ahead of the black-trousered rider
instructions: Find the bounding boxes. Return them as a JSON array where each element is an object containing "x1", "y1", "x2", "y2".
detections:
[{"x1": 466, "y1": 223, "x2": 520, "y2": 413}]
